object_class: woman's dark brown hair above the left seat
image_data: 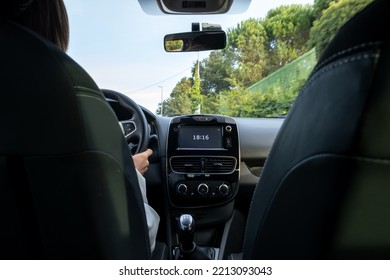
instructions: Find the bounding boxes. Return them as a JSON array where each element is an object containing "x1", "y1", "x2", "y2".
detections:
[{"x1": 12, "y1": 0, "x2": 69, "y2": 51}]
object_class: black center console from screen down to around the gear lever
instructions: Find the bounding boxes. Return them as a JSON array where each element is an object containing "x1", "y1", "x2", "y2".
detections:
[{"x1": 167, "y1": 115, "x2": 240, "y2": 256}]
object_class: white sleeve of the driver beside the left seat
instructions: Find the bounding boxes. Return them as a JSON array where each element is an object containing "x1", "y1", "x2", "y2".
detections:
[{"x1": 136, "y1": 170, "x2": 160, "y2": 252}]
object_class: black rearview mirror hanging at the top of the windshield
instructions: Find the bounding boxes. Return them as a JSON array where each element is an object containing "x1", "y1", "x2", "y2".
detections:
[{"x1": 164, "y1": 30, "x2": 226, "y2": 52}]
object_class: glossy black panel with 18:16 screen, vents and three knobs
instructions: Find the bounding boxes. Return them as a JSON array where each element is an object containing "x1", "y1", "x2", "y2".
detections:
[{"x1": 167, "y1": 115, "x2": 240, "y2": 207}]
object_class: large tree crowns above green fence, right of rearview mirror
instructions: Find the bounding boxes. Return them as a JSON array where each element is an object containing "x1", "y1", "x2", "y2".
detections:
[{"x1": 223, "y1": 5, "x2": 314, "y2": 89}]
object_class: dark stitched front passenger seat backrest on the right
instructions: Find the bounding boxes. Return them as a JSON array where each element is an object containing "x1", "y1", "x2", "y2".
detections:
[{"x1": 243, "y1": 0, "x2": 390, "y2": 259}]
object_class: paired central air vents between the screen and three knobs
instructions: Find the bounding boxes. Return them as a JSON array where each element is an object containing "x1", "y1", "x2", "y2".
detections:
[{"x1": 170, "y1": 157, "x2": 237, "y2": 174}]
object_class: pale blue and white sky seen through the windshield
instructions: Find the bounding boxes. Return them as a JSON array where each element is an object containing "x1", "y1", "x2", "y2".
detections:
[{"x1": 64, "y1": 0, "x2": 313, "y2": 112}]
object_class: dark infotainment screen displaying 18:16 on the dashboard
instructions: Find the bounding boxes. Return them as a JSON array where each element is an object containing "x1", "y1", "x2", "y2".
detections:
[{"x1": 178, "y1": 126, "x2": 223, "y2": 149}]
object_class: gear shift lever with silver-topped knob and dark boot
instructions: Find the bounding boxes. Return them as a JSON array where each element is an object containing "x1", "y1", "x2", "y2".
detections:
[{"x1": 179, "y1": 214, "x2": 196, "y2": 254}]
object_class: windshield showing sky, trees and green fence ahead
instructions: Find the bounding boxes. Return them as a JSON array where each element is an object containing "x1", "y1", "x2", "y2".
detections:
[{"x1": 65, "y1": 0, "x2": 370, "y2": 117}]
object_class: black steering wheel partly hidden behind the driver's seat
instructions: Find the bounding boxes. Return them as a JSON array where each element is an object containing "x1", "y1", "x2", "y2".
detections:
[{"x1": 101, "y1": 89, "x2": 150, "y2": 155}]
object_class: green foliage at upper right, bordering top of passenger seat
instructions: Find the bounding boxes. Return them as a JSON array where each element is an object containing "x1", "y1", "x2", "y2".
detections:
[{"x1": 308, "y1": 0, "x2": 372, "y2": 57}]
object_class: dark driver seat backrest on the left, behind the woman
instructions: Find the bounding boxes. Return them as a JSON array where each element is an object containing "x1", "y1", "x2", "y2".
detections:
[{"x1": 0, "y1": 12, "x2": 151, "y2": 259}]
